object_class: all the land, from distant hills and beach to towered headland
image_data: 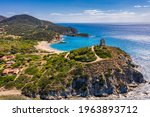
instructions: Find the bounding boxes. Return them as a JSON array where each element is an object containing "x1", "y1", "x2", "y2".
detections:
[{"x1": 0, "y1": 15, "x2": 145, "y2": 99}]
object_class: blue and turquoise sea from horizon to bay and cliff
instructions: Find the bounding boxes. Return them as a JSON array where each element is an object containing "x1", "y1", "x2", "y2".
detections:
[{"x1": 51, "y1": 24, "x2": 150, "y2": 99}]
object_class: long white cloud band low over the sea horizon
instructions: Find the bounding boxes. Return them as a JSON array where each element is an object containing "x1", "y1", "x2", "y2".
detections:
[{"x1": 49, "y1": 9, "x2": 150, "y2": 23}]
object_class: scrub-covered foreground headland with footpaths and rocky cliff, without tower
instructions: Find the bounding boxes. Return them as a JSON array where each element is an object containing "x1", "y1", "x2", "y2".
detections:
[{"x1": 0, "y1": 39, "x2": 145, "y2": 99}]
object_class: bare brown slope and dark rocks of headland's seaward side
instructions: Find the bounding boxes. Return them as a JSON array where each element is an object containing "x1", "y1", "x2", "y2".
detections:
[{"x1": 30, "y1": 47, "x2": 145, "y2": 99}]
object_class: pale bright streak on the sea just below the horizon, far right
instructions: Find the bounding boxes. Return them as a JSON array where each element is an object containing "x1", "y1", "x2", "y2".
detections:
[{"x1": 110, "y1": 35, "x2": 150, "y2": 43}]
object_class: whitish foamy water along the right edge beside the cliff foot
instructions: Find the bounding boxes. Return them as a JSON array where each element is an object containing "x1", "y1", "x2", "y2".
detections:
[{"x1": 119, "y1": 49, "x2": 150, "y2": 100}]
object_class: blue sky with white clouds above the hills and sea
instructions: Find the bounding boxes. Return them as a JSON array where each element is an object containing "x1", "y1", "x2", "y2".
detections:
[{"x1": 0, "y1": 0, "x2": 150, "y2": 23}]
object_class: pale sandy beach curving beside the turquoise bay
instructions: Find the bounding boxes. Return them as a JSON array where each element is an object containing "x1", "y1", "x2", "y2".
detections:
[{"x1": 35, "y1": 41, "x2": 64, "y2": 54}]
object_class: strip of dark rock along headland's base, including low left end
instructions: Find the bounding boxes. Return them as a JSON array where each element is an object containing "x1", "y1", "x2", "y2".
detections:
[{"x1": 40, "y1": 66, "x2": 145, "y2": 99}]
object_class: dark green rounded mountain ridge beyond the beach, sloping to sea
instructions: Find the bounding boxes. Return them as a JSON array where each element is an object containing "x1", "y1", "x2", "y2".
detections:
[{"x1": 0, "y1": 14, "x2": 77, "y2": 40}]
